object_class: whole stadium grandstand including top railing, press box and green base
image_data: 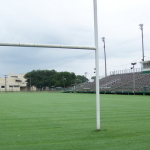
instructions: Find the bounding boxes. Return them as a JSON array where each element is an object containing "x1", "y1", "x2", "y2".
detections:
[{"x1": 66, "y1": 61, "x2": 150, "y2": 95}]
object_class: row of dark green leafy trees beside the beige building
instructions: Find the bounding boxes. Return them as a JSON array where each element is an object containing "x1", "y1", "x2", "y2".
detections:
[{"x1": 24, "y1": 70, "x2": 88, "y2": 88}]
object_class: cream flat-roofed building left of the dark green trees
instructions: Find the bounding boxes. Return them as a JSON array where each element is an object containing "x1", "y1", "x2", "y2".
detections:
[{"x1": 0, "y1": 73, "x2": 36, "y2": 92}]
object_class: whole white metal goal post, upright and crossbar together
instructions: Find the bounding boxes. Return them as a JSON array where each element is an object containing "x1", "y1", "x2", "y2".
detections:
[{"x1": 0, "y1": 0, "x2": 100, "y2": 130}]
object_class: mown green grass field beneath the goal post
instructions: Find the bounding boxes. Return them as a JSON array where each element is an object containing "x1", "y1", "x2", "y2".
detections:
[{"x1": 0, "y1": 93, "x2": 150, "y2": 150}]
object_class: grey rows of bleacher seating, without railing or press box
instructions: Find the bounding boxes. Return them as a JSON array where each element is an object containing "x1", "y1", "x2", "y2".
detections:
[{"x1": 76, "y1": 72, "x2": 150, "y2": 92}]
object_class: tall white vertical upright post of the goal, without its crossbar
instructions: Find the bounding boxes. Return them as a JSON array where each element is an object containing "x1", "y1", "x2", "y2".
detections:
[{"x1": 93, "y1": 0, "x2": 100, "y2": 130}]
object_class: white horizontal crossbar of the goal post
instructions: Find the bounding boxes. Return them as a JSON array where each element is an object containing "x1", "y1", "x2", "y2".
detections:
[{"x1": 0, "y1": 43, "x2": 96, "y2": 50}]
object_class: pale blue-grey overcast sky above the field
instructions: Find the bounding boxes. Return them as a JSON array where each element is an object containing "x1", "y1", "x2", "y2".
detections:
[{"x1": 0, "y1": 0, "x2": 150, "y2": 78}]
